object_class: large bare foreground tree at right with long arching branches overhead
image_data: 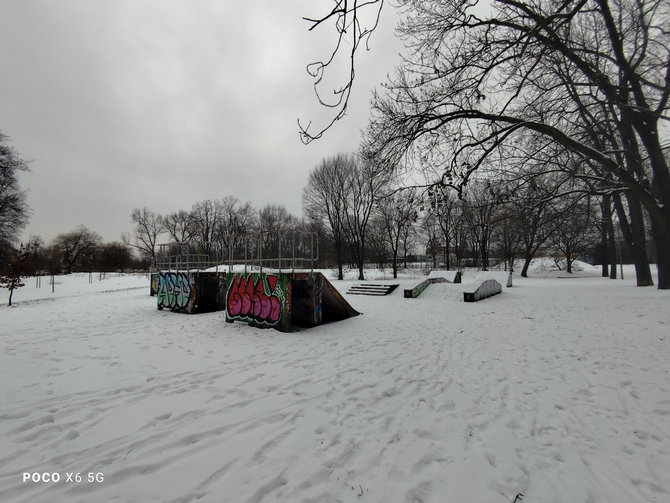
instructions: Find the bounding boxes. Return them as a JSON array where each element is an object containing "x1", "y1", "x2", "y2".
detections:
[{"x1": 367, "y1": 0, "x2": 670, "y2": 289}]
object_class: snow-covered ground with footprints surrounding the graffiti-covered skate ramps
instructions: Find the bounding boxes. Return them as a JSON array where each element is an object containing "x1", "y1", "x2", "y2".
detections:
[{"x1": 0, "y1": 266, "x2": 670, "y2": 503}]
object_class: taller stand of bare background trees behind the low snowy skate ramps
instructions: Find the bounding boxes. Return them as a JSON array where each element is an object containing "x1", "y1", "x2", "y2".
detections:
[{"x1": 303, "y1": 153, "x2": 636, "y2": 279}]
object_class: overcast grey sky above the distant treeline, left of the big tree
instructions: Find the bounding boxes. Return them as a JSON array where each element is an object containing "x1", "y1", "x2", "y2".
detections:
[{"x1": 0, "y1": 0, "x2": 401, "y2": 241}]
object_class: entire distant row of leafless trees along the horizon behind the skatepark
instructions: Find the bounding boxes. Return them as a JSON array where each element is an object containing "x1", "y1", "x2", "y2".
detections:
[{"x1": 4, "y1": 130, "x2": 651, "y2": 304}]
